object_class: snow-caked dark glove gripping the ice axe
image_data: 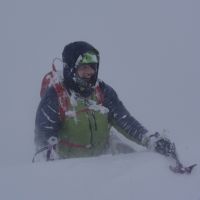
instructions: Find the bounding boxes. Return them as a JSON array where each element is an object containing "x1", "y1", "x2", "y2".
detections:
[{"x1": 147, "y1": 132, "x2": 176, "y2": 158}]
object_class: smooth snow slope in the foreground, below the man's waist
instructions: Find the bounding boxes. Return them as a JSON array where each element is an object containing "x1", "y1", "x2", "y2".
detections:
[{"x1": 0, "y1": 152, "x2": 200, "y2": 200}]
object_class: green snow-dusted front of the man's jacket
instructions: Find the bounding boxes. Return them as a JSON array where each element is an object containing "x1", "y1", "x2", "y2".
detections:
[{"x1": 58, "y1": 86, "x2": 110, "y2": 158}]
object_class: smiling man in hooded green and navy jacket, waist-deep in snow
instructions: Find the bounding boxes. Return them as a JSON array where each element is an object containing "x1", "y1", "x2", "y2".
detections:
[{"x1": 35, "y1": 41, "x2": 175, "y2": 160}]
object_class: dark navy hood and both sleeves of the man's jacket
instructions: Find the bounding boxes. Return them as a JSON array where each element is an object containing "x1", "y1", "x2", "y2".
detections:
[{"x1": 35, "y1": 42, "x2": 147, "y2": 148}]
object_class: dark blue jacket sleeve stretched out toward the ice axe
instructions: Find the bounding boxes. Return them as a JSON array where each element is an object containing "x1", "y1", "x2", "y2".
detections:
[{"x1": 100, "y1": 82, "x2": 148, "y2": 145}]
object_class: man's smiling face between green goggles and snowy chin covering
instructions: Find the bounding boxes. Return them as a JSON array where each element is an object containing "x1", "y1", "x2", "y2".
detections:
[{"x1": 77, "y1": 64, "x2": 96, "y2": 80}]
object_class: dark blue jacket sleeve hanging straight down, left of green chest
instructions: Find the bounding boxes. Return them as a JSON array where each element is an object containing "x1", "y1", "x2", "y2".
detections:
[{"x1": 35, "y1": 87, "x2": 61, "y2": 148}]
